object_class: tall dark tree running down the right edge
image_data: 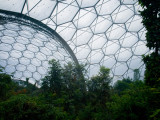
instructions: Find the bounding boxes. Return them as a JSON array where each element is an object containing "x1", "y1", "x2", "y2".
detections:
[{"x1": 139, "y1": 0, "x2": 160, "y2": 87}]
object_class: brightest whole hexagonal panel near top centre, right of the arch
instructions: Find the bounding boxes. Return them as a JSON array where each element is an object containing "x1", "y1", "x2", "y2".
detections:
[{"x1": 73, "y1": 8, "x2": 97, "y2": 28}]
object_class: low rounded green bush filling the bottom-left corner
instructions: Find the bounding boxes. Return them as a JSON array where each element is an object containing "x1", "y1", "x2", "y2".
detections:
[{"x1": 0, "y1": 95, "x2": 66, "y2": 120}]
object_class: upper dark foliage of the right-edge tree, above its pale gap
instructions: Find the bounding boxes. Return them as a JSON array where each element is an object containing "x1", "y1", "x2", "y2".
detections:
[{"x1": 139, "y1": 0, "x2": 160, "y2": 54}]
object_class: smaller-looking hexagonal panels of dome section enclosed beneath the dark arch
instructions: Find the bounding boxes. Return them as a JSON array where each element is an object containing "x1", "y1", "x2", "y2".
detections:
[{"x1": 0, "y1": 23, "x2": 72, "y2": 83}]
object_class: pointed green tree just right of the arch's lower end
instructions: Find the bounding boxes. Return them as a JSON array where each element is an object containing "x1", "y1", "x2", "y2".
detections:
[{"x1": 87, "y1": 66, "x2": 112, "y2": 105}]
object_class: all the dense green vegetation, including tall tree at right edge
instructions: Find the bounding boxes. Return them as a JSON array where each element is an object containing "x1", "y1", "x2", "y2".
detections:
[{"x1": 0, "y1": 0, "x2": 160, "y2": 120}]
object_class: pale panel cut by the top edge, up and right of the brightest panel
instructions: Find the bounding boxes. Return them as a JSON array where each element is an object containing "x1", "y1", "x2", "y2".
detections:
[{"x1": 96, "y1": 0, "x2": 120, "y2": 15}]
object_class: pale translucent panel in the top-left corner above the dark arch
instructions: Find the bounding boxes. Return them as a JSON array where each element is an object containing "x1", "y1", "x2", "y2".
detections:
[{"x1": 0, "y1": 0, "x2": 25, "y2": 12}]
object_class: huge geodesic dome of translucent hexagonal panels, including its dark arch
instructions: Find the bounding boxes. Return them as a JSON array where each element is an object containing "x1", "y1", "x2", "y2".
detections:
[{"x1": 0, "y1": 0, "x2": 149, "y2": 83}]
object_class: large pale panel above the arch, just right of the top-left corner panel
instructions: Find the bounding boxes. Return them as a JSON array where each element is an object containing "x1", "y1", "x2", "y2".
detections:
[{"x1": 29, "y1": 0, "x2": 56, "y2": 20}]
